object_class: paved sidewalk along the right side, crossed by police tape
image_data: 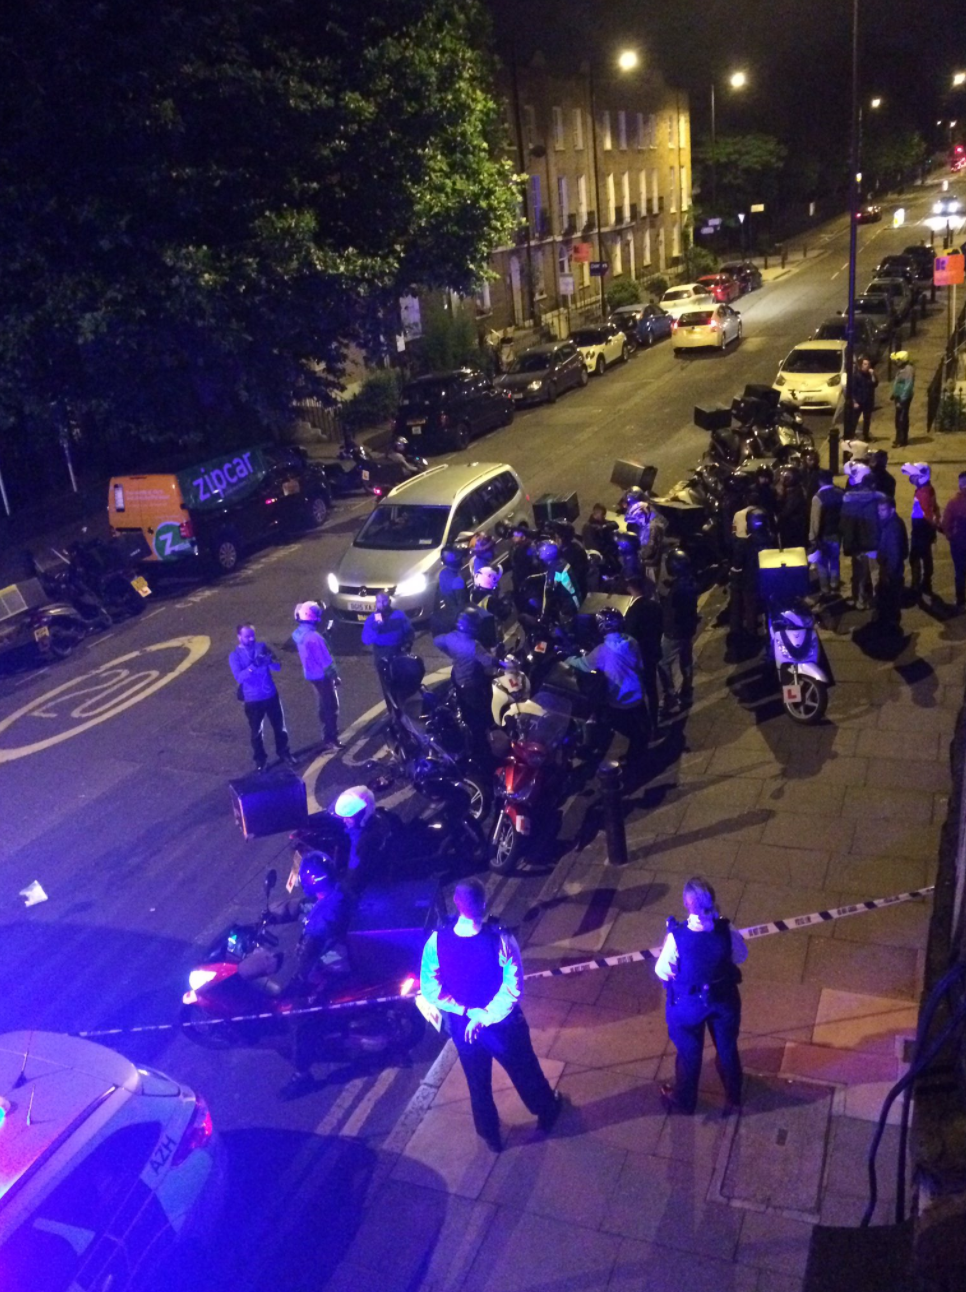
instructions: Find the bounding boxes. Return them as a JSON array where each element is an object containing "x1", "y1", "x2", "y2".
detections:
[{"x1": 309, "y1": 270, "x2": 966, "y2": 1292}]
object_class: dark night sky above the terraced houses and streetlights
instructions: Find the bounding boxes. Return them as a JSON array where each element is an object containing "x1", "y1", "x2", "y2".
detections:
[{"x1": 487, "y1": 0, "x2": 966, "y2": 151}]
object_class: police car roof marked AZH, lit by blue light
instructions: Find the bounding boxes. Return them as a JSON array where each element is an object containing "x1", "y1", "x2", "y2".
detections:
[{"x1": 0, "y1": 1031, "x2": 218, "y2": 1292}]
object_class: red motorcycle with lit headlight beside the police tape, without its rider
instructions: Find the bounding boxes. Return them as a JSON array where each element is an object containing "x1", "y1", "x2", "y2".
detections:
[{"x1": 180, "y1": 870, "x2": 437, "y2": 1054}]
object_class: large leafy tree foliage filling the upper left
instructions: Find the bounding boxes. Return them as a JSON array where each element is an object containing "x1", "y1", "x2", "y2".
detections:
[{"x1": 0, "y1": 0, "x2": 517, "y2": 465}]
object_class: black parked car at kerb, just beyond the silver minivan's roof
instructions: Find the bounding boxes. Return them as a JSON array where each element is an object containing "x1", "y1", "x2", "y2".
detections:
[{"x1": 394, "y1": 368, "x2": 513, "y2": 452}]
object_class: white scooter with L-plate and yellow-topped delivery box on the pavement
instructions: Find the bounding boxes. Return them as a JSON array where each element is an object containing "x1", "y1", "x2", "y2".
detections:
[{"x1": 758, "y1": 548, "x2": 833, "y2": 725}]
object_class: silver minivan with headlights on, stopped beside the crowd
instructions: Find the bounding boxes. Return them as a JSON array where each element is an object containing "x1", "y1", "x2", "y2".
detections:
[{"x1": 325, "y1": 463, "x2": 533, "y2": 623}]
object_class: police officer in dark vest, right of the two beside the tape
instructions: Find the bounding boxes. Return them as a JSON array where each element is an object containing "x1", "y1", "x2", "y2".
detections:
[{"x1": 655, "y1": 875, "x2": 748, "y2": 1115}]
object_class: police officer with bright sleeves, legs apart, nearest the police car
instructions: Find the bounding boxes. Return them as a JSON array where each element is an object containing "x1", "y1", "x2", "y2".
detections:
[{"x1": 420, "y1": 879, "x2": 563, "y2": 1152}]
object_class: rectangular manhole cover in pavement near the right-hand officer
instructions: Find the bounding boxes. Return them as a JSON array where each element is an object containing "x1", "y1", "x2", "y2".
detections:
[{"x1": 712, "y1": 1078, "x2": 834, "y2": 1220}]
